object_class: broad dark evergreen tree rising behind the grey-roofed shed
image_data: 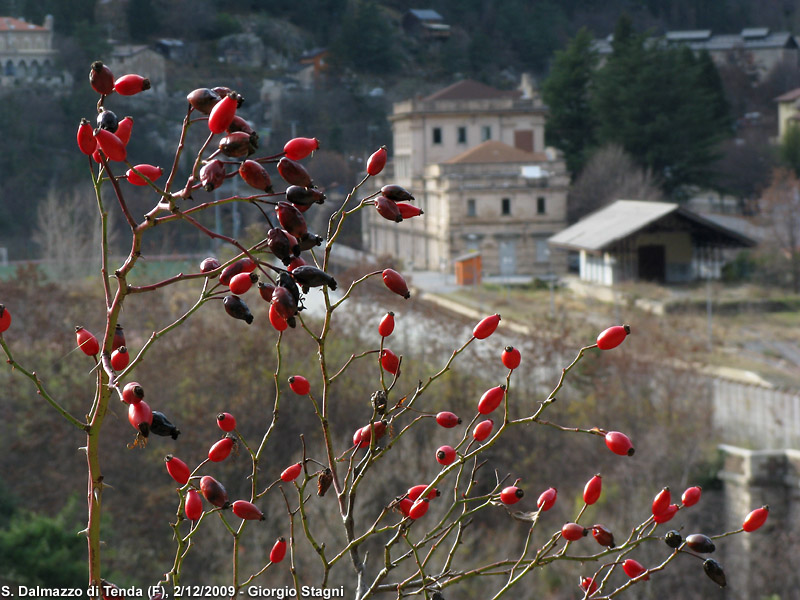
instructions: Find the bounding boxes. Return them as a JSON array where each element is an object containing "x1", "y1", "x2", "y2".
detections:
[{"x1": 593, "y1": 19, "x2": 730, "y2": 197}]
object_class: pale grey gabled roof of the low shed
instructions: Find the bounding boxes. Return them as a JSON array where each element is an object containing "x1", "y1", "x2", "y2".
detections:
[{"x1": 548, "y1": 200, "x2": 755, "y2": 252}]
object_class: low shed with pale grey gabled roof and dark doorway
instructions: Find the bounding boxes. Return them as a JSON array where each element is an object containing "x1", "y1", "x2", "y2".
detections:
[{"x1": 550, "y1": 200, "x2": 756, "y2": 285}]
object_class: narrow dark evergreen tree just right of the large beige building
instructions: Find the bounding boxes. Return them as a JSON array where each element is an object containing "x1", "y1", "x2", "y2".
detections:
[{"x1": 542, "y1": 28, "x2": 598, "y2": 178}]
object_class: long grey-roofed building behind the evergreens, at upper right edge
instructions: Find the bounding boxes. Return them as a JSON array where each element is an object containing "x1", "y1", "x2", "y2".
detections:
[{"x1": 594, "y1": 27, "x2": 800, "y2": 82}]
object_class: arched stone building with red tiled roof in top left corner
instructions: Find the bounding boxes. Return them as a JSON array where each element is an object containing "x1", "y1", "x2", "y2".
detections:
[{"x1": 0, "y1": 15, "x2": 69, "y2": 87}]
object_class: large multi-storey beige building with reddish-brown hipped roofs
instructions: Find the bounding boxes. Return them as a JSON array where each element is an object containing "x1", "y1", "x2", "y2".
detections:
[{"x1": 364, "y1": 80, "x2": 569, "y2": 276}]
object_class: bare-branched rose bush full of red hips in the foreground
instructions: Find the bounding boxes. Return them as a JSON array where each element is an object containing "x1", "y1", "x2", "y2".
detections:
[{"x1": 0, "y1": 61, "x2": 768, "y2": 599}]
